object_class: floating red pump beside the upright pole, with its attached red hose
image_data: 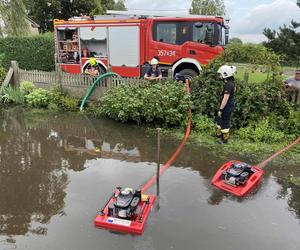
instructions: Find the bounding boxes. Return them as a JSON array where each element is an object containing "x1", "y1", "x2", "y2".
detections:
[{"x1": 94, "y1": 80, "x2": 192, "y2": 235}]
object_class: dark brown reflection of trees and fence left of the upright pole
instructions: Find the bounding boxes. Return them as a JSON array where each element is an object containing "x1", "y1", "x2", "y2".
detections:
[{"x1": 0, "y1": 108, "x2": 172, "y2": 235}]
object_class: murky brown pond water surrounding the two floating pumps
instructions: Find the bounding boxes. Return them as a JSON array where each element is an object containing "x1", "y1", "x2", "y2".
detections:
[{"x1": 0, "y1": 109, "x2": 300, "y2": 250}]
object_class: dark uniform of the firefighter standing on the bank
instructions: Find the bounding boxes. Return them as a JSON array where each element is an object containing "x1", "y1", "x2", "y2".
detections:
[{"x1": 216, "y1": 80, "x2": 235, "y2": 143}]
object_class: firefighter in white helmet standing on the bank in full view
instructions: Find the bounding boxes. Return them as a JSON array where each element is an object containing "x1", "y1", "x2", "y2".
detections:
[{"x1": 216, "y1": 65, "x2": 236, "y2": 144}]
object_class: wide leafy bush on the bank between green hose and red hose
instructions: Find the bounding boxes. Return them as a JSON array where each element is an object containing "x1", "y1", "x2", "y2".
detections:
[{"x1": 93, "y1": 82, "x2": 190, "y2": 126}]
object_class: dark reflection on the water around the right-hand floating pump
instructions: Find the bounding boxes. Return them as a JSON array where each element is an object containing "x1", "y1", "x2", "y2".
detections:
[{"x1": 169, "y1": 143, "x2": 300, "y2": 211}]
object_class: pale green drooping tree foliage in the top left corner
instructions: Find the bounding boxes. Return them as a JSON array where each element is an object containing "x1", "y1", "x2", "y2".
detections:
[{"x1": 0, "y1": 0, "x2": 29, "y2": 36}]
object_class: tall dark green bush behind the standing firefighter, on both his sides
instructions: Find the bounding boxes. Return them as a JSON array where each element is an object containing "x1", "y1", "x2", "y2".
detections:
[{"x1": 191, "y1": 59, "x2": 290, "y2": 128}]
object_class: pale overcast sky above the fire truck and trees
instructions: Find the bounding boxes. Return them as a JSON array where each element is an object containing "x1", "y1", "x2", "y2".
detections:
[{"x1": 125, "y1": 0, "x2": 300, "y2": 43}]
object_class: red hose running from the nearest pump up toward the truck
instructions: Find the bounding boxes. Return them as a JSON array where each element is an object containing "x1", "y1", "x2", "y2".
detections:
[{"x1": 141, "y1": 80, "x2": 192, "y2": 193}]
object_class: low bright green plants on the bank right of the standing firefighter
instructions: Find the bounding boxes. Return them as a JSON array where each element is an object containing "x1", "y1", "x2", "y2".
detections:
[{"x1": 237, "y1": 119, "x2": 285, "y2": 143}]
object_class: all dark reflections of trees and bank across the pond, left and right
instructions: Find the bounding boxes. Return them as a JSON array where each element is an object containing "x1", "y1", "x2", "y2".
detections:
[{"x1": 0, "y1": 109, "x2": 300, "y2": 244}]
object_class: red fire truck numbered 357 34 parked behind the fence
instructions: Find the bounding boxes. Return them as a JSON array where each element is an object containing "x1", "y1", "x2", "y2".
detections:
[{"x1": 54, "y1": 11, "x2": 228, "y2": 77}]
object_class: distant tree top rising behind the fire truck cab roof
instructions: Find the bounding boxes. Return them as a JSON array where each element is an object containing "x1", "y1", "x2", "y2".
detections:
[{"x1": 190, "y1": 0, "x2": 226, "y2": 16}]
